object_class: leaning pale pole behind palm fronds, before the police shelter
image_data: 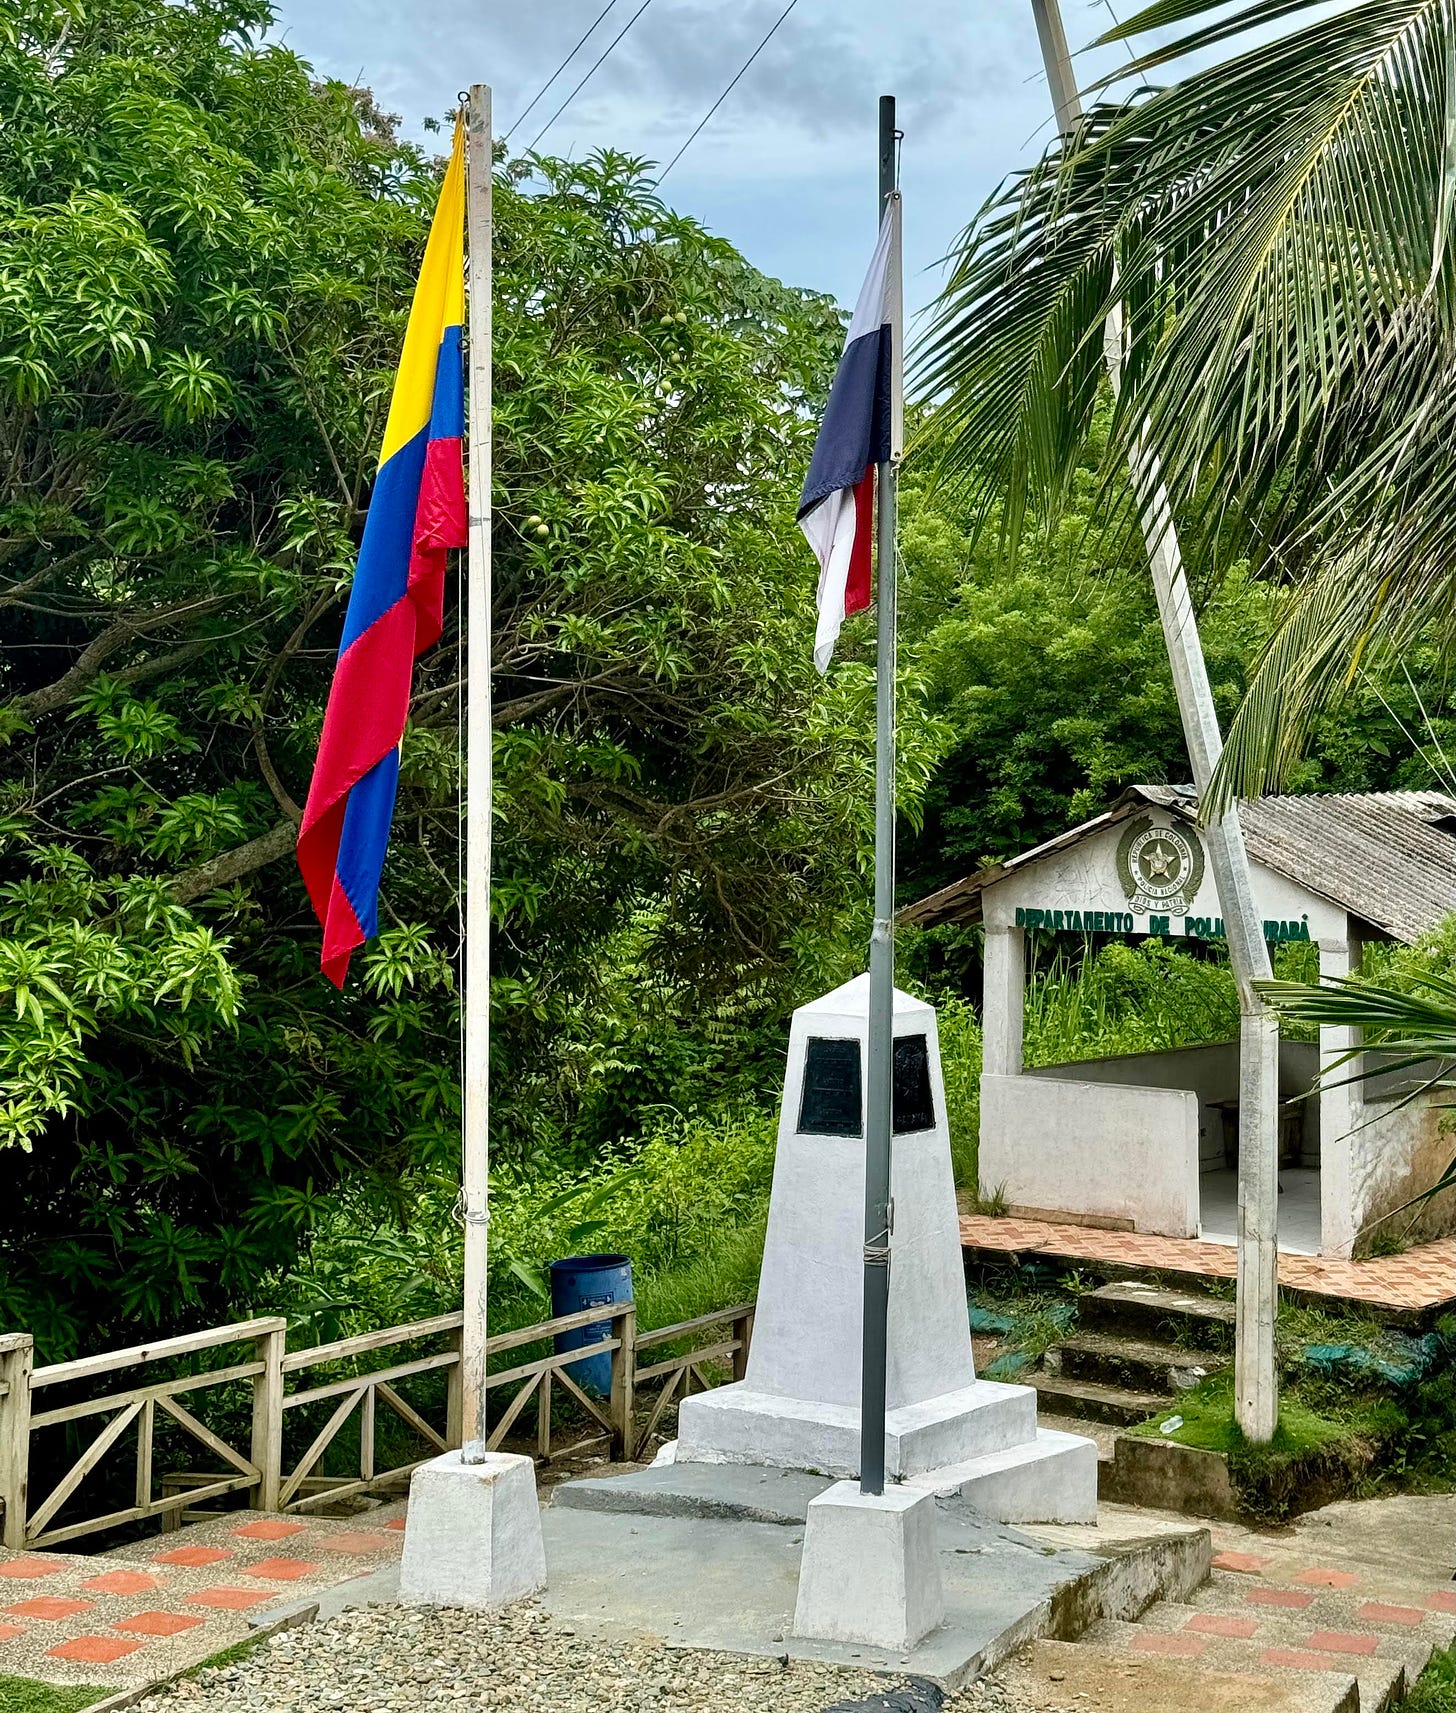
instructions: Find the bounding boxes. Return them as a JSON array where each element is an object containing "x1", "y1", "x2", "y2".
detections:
[{"x1": 1031, "y1": 0, "x2": 1280, "y2": 1442}]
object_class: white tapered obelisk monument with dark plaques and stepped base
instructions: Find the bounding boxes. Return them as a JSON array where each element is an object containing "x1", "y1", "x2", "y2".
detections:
[{"x1": 675, "y1": 976, "x2": 1096, "y2": 1523}]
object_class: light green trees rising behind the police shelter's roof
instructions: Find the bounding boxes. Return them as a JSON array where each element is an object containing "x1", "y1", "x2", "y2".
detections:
[{"x1": 901, "y1": 462, "x2": 1456, "y2": 899}]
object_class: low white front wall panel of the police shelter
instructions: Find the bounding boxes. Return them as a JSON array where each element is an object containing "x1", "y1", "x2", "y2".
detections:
[{"x1": 980, "y1": 1076, "x2": 1199, "y2": 1237}]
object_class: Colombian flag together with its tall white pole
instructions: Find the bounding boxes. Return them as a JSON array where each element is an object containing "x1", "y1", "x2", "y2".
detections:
[{"x1": 298, "y1": 97, "x2": 492, "y2": 1461}]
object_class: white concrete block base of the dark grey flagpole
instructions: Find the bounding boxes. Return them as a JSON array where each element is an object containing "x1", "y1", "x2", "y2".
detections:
[{"x1": 793, "y1": 1482, "x2": 946, "y2": 1653}]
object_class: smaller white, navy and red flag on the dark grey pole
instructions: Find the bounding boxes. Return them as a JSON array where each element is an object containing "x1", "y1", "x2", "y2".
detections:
[{"x1": 798, "y1": 195, "x2": 901, "y2": 671}]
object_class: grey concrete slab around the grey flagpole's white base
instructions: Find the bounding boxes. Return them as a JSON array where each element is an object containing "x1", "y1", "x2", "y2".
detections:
[{"x1": 543, "y1": 1465, "x2": 1211, "y2": 1689}]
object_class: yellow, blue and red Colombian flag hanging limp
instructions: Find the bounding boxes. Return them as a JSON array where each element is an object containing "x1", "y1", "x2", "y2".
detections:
[{"x1": 298, "y1": 125, "x2": 466, "y2": 987}]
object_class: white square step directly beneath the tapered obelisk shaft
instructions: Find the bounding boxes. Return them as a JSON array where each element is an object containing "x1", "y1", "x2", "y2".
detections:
[{"x1": 677, "y1": 1381, "x2": 1036, "y2": 1480}]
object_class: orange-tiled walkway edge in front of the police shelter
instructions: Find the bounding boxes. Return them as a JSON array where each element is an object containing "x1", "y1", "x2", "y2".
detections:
[{"x1": 961, "y1": 1215, "x2": 1456, "y2": 1312}]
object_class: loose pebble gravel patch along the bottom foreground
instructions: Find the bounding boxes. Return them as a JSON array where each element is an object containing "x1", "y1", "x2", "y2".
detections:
[{"x1": 139, "y1": 1605, "x2": 1059, "y2": 1713}]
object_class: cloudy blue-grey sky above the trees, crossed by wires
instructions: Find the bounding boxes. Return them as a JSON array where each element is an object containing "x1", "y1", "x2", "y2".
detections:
[{"x1": 267, "y1": 0, "x2": 1131, "y2": 307}]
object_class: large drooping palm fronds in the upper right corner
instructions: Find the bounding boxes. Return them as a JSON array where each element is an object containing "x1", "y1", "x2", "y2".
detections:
[{"x1": 923, "y1": 0, "x2": 1456, "y2": 790}]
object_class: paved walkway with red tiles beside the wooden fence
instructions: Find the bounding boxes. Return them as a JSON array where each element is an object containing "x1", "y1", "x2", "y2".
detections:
[{"x1": 0, "y1": 1501, "x2": 404, "y2": 1689}]
